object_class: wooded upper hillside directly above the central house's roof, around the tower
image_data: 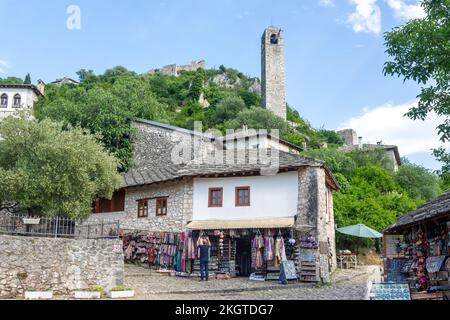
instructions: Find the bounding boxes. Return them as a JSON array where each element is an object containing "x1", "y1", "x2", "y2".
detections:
[{"x1": 35, "y1": 66, "x2": 342, "y2": 170}]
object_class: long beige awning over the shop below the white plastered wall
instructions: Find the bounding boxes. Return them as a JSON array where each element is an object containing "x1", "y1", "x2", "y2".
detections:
[{"x1": 186, "y1": 217, "x2": 295, "y2": 230}]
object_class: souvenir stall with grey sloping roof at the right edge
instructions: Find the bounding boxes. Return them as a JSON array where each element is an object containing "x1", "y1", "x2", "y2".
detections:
[{"x1": 383, "y1": 192, "x2": 450, "y2": 299}]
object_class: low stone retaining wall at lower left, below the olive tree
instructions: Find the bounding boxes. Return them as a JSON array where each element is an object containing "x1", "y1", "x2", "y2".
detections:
[{"x1": 0, "y1": 235, "x2": 124, "y2": 297}]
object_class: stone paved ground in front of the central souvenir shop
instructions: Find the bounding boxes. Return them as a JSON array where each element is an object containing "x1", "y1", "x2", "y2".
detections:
[{"x1": 125, "y1": 265, "x2": 379, "y2": 300}]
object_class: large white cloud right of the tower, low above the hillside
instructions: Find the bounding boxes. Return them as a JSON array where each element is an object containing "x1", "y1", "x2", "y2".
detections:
[{"x1": 339, "y1": 101, "x2": 442, "y2": 156}]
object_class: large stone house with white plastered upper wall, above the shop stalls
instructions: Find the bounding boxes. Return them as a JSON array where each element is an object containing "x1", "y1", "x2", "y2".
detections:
[{"x1": 89, "y1": 119, "x2": 338, "y2": 279}]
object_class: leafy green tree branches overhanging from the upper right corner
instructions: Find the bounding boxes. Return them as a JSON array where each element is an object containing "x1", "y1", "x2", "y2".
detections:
[{"x1": 384, "y1": 0, "x2": 450, "y2": 180}]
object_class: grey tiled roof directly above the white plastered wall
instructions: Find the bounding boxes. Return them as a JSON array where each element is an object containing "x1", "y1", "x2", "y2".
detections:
[{"x1": 122, "y1": 150, "x2": 333, "y2": 188}]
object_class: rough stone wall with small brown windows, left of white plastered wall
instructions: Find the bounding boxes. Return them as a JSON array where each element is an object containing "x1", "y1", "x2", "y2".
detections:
[{"x1": 93, "y1": 178, "x2": 193, "y2": 232}]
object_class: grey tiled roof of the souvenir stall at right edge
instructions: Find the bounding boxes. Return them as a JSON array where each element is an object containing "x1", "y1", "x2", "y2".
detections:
[{"x1": 384, "y1": 189, "x2": 450, "y2": 232}]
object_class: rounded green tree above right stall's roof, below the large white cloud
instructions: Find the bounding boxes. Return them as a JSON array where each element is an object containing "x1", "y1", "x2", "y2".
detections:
[{"x1": 395, "y1": 158, "x2": 441, "y2": 201}]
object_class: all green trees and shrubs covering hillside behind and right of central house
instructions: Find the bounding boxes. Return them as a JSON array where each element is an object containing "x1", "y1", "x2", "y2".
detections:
[{"x1": 22, "y1": 66, "x2": 442, "y2": 248}]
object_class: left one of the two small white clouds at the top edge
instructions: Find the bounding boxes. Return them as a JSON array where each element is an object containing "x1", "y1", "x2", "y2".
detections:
[{"x1": 346, "y1": 0, "x2": 381, "y2": 34}]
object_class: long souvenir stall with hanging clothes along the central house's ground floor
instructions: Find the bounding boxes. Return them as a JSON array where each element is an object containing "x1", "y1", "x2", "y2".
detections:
[{"x1": 121, "y1": 222, "x2": 328, "y2": 283}]
